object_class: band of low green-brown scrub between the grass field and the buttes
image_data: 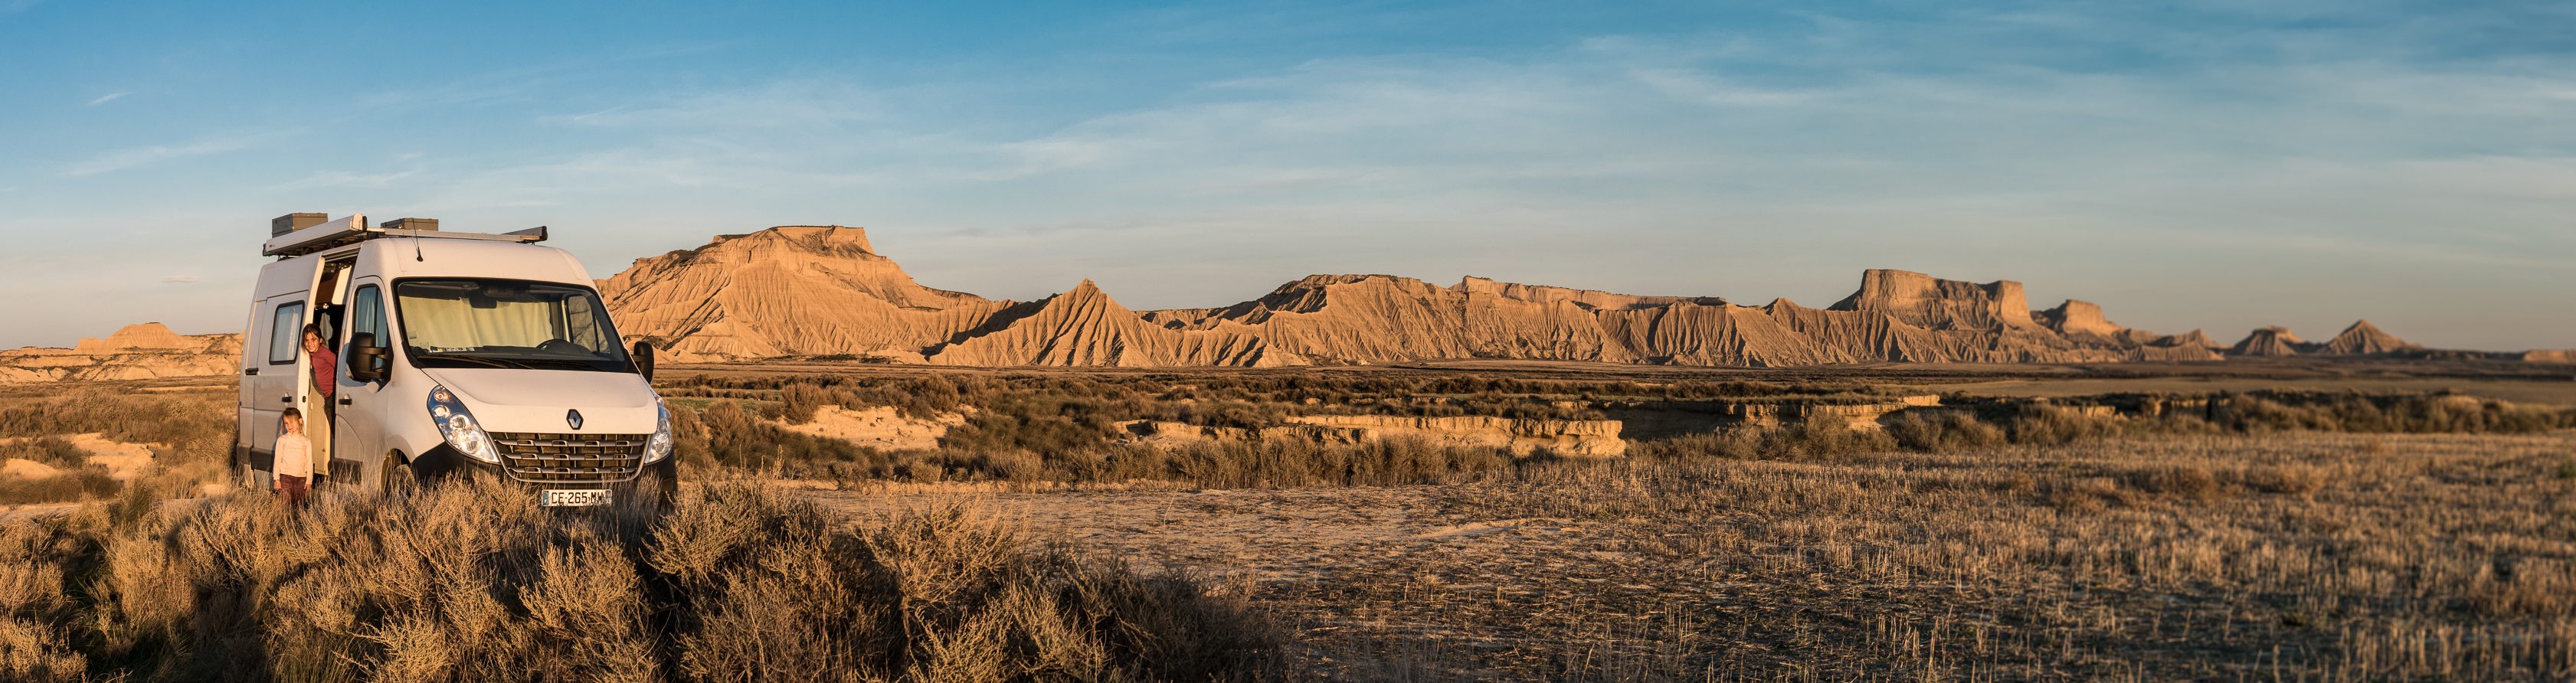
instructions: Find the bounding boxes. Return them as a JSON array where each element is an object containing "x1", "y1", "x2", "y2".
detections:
[{"x1": 667, "y1": 374, "x2": 2576, "y2": 490}]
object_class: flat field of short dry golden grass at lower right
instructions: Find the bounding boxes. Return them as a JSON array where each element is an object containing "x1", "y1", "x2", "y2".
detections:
[{"x1": 1265, "y1": 433, "x2": 2576, "y2": 681}]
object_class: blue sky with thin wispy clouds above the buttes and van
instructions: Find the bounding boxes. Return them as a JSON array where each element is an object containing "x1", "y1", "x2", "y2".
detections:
[{"x1": 0, "y1": 0, "x2": 2576, "y2": 348}]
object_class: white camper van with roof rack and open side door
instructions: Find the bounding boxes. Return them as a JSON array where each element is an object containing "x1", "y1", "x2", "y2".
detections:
[{"x1": 234, "y1": 214, "x2": 677, "y2": 505}]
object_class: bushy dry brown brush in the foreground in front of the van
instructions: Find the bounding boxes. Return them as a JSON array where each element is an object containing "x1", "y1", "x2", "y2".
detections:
[{"x1": 0, "y1": 476, "x2": 1278, "y2": 681}]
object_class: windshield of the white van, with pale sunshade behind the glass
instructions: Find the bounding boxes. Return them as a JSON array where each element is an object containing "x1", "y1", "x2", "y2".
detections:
[{"x1": 394, "y1": 279, "x2": 633, "y2": 371}]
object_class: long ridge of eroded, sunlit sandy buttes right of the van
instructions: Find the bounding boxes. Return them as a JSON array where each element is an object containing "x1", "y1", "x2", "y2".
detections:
[{"x1": 601, "y1": 227, "x2": 2463, "y2": 366}]
